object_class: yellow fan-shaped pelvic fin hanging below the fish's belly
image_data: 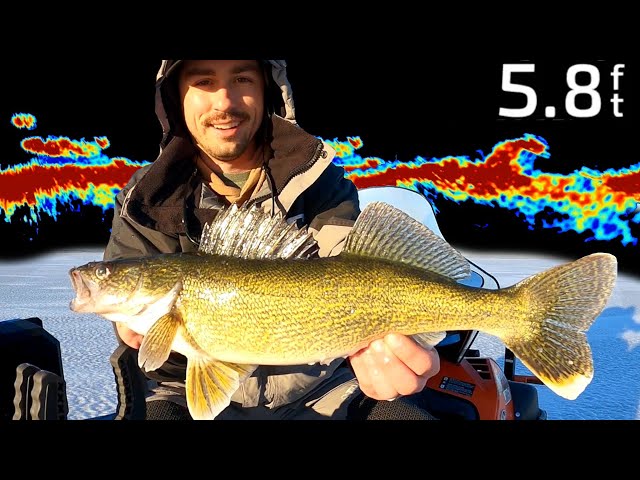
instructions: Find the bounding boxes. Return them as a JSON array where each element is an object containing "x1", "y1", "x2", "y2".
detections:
[{"x1": 186, "y1": 358, "x2": 257, "y2": 420}]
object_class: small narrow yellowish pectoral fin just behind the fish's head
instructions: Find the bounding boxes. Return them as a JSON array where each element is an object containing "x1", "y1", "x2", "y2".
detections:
[{"x1": 138, "y1": 310, "x2": 182, "y2": 372}]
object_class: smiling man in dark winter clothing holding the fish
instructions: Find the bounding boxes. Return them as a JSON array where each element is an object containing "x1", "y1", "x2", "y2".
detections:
[{"x1": 104, "y1": 60, "x2": 439, "y2": 419}]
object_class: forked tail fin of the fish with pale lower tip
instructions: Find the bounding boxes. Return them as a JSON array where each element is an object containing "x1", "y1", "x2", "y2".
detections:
[{"x1": 503, "y1": 253, "x2": 617, "y2": 400}]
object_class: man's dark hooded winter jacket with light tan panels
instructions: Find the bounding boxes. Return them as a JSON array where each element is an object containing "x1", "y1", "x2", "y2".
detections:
[{"x1": 104, "y1": 60, "x2": 360, "y2": 408}]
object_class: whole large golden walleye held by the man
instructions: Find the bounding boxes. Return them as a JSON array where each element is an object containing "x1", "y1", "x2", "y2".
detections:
[{"x1": 70, "y1": 202, "x2": 617, "y2": 419}]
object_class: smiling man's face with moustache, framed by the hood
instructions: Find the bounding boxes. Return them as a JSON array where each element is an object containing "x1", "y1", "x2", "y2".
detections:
[{"x1": 178, "y1": 60, "x2": 265, "y2": 162}]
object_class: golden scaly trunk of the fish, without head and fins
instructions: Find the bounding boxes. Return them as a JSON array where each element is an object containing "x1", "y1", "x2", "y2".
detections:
[{"x1": 176, "y1": 254, "x2": 504, "y2": 365}]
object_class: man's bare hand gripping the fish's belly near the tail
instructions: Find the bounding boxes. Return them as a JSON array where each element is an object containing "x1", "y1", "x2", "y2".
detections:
[{"x1": 349, "y1": 334, "x2": 440, "y2": 400}]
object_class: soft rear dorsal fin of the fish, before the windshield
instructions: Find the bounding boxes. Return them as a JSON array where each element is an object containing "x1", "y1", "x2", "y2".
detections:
[{"x1": 343, "y1": 202, "x2": 471, "y2": 280}]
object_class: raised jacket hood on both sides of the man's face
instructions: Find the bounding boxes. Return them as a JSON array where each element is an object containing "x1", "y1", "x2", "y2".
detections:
[{"x1": 156, "y1": 60, "x2": 296, "y2": 149}]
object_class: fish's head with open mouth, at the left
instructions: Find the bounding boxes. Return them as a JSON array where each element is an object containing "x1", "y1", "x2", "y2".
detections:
[{"x1": 69, "y1": 259, "x2": 175, "y2": 321}]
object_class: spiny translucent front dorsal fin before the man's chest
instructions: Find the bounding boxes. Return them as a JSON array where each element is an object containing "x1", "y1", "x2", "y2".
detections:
[{"x1": 199, "y1": 204, "x2": 318, "y2": 259}]
